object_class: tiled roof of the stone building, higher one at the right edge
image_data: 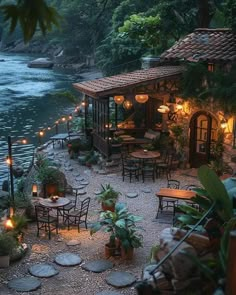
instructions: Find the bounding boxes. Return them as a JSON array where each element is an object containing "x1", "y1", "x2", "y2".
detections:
[{"x1": 161, "y1": 29, "x2": 236, "y2": 63}]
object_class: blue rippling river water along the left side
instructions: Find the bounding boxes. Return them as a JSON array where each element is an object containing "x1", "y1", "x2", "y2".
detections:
[{"x1": 0, "y1": 53, "x2": 79, "y2": 184}]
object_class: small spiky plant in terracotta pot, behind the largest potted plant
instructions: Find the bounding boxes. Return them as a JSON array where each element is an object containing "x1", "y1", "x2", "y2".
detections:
[{"x1": 96, "y1": 184, "x2": 121, "y2": 212}]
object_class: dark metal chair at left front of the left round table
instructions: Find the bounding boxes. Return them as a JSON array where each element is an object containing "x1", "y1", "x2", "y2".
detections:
[{"x1": 35, "y1": 205, "x2": 58, "y2": 240}]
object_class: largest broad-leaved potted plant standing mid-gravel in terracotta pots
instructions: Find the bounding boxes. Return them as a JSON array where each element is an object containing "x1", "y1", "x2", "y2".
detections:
[{"x1": 90, "y1": 203, "x2": 142, "y2": 257}]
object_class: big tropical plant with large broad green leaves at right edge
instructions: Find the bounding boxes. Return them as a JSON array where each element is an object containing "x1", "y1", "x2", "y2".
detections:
[{"x1": 178, "y1": 165, "x2": 236, "y2": 288}]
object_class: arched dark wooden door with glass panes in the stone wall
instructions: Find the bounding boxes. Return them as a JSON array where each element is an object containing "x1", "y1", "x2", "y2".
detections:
[{"x1": 189, "y1": 111, "x2": 218, "y2": 168}]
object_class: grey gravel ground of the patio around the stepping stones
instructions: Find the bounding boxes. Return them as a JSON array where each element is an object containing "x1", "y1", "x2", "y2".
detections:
[{"x1": 0, "y1": 146, "x2": 198, "y2": 295}]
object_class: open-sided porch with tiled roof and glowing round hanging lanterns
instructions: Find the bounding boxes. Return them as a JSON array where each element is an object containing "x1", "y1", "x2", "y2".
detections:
[{"x1": 73, "y1": 66, "x2": 184, "y2": 157}]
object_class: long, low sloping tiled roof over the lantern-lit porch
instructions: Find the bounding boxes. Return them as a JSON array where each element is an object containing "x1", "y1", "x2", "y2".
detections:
[{"x1": 73, "y1": 66, "x2": 184, "y2": 98}]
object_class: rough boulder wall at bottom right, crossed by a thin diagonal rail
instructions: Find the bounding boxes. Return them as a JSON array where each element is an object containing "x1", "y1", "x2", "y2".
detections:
[{"x1": 143, "y1": 228, "x2": 212, "y2": 295}]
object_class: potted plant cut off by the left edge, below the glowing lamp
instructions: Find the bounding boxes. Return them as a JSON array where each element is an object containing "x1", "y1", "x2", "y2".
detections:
[{"x1": 0, "y1": 232, "x2": 17, "y2": 268}]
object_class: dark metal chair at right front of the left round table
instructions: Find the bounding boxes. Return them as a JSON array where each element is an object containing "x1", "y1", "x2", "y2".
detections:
[{"x1": 64, "y1": 197, "x2": 91, "y2": 232}]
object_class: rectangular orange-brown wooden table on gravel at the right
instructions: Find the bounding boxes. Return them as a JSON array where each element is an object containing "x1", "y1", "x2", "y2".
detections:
[{"x1": 156, "y1": 188, "x2": 196, "y2": 216}]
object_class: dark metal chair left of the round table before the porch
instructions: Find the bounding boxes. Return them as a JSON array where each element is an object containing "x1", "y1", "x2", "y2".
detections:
[{"x1": 121, "y1": 154, "x2": 140, "y2": 182}]
